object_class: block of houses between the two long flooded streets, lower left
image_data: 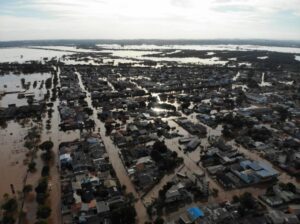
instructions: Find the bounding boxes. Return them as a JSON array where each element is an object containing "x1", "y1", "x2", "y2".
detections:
[{"x1": 59, "y1": 134, "x2": 132, "y2": 224}]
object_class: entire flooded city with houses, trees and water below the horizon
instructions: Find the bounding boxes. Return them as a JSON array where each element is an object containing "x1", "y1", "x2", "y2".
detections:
[{"x1": 0, "y1": 42, "x2": 300, "y2": 224}]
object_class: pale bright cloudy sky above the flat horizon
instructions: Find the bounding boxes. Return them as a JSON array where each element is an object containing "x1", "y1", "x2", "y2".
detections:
[{"x1": 0, "y1": 0, "x2": 300, "y2": 41}]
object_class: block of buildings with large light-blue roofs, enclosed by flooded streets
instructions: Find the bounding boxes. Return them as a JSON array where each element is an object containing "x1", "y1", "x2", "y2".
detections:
[{"x1": 201, "y1": 139, "x2": 279, "y2": 189}]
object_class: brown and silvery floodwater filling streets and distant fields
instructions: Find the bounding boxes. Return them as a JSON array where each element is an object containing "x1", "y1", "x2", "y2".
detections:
[{"x1": 0, "y1": 46, "x2": 300, "y2": 224}]
